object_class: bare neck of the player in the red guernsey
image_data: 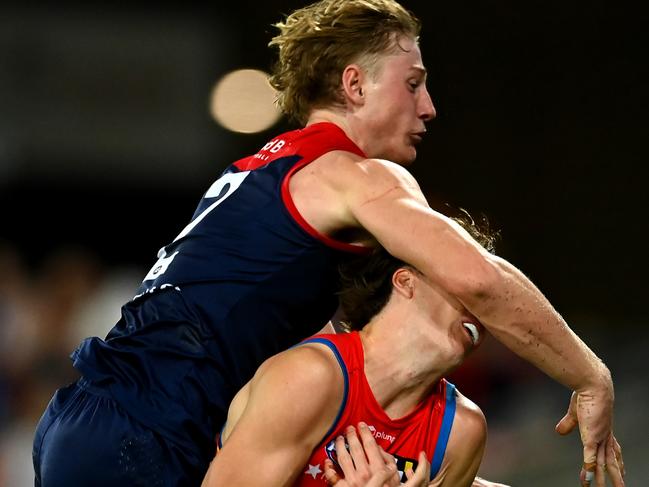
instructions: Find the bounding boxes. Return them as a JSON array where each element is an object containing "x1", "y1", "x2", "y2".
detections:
[{"x1": 360, "y1": 315, "x2": 453, "y2": 418}]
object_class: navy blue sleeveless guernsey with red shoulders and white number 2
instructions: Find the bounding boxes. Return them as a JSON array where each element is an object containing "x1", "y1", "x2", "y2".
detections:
[{"x1": 72, "y1": 123, "x2": 366, "y2": 461}]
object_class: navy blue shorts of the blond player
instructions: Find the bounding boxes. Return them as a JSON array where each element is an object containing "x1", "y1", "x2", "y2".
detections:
[{"x1": 32, "y1": 379, "x2": 207, "y2": 487}]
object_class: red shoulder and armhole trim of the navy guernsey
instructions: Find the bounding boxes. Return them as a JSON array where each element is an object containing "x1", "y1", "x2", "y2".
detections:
[{"x1": 282, "y1": 122, "x2": 371, "y2": 254}]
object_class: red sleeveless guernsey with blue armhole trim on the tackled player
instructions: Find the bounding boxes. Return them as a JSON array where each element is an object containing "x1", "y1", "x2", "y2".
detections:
[{"x1": 295, "y1": 332, "x2": 456, "y2": 487}]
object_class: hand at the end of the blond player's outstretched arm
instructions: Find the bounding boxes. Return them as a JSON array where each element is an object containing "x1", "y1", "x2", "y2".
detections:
[{"x1": 556, "y1": 387, "x2": 625, "y2": 487}]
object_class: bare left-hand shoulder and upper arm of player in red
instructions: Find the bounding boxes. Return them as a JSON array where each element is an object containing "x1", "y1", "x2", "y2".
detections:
[{"x1": 202, "y1": 345, "x2": 343, "y2": 487}]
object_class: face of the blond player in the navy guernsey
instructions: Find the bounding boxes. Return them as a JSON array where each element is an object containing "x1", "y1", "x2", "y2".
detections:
[{"x1": 358, "y1": 37, "x2": 436, "y2": 165}]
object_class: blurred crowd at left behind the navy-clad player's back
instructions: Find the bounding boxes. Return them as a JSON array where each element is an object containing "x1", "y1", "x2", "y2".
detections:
[{"x1": 0, "y1": 241, "x2": 139, "y2": 487}]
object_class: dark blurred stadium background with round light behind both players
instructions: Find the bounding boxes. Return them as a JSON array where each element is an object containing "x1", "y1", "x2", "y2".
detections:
[{"x1": 0, "y1": 0, "x2": 649, "y2": 487}]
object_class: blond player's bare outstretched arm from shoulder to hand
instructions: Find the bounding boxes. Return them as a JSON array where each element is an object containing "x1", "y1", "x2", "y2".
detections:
[{"x1": 312, "y1": 157, "x2": 623, "y2": 487}]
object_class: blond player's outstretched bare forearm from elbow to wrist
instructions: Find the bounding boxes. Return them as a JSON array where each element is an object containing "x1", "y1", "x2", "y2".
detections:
[{"x1": 465, "y1": 257, "x2": 610, "y2": 390}]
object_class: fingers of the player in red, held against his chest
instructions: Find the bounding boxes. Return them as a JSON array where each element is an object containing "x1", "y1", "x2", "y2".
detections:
[{"x1": 324, "y1": 423, "x2": 430, "y2": 487}]
